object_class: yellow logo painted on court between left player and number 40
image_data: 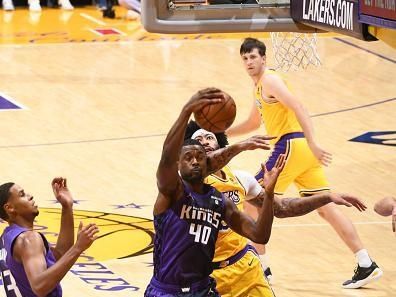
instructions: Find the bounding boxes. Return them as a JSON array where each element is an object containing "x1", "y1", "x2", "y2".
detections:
[{"x1": 0, "y1": 208, "x2": 154, "y2": 261}]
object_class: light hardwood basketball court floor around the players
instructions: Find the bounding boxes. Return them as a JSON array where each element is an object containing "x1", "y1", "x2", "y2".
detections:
[{"x1": 0, "y1": 9, "x2": 396, "y2": 297}]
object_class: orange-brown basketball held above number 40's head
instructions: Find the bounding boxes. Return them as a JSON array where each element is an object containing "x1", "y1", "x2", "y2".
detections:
[{"x1": 194, "y1": 92, "x2": 236, "y2": 133}]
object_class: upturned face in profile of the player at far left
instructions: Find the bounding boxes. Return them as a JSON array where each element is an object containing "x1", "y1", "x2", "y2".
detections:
[{"x1": 6, "y1": 185, "x2": 39, "y2": 219}]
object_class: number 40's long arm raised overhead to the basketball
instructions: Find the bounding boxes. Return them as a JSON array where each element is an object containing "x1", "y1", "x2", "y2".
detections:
[{"x1": 154, "y1": 88, "x2": 223, "y2": 213}]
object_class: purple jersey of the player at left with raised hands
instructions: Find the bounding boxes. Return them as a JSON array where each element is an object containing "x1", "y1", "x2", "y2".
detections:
[{"x1": 0, "y1": 224, "x2": 62, "y2": 297}]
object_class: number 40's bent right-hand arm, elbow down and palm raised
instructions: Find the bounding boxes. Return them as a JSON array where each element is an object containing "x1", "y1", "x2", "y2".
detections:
[{"x1": 225, "y1": 155, "x2": 285, "y2": 244}]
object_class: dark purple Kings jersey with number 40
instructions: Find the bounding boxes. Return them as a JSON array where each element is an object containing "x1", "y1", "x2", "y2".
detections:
[{"x1": 154, "y1": 184, "x2": 225, "y2": 287}]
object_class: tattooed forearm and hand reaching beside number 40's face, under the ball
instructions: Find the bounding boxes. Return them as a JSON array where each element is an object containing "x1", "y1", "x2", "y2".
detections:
[{"x1": 208, "y1": 135, "x2": 275, "y2": 175}]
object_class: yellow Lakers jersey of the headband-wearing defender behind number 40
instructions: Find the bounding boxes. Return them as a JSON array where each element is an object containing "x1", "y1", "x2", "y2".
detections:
[{"x1": 205, "y1": 166, "x2": 248, "y2": 262}]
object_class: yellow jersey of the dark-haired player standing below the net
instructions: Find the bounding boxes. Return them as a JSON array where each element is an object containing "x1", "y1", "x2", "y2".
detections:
[{"x1": 254, "y1": 69, "x2": 302, "y2": 143}]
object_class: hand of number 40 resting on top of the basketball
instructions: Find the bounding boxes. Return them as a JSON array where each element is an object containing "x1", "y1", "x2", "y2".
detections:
[{"x1": 184, "y1": 88, "x2": 225, "y2": 113}]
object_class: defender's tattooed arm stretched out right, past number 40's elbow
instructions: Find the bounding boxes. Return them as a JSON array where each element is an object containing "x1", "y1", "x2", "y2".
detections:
[{"x1": 248, "y1": 190, "x2": 367, "y2": 218}]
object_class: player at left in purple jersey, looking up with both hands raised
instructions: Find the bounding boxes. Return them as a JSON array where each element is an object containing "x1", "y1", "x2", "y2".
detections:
[{"x1": 0, "y1": 177, "x2": 98, "y2": 297}]
